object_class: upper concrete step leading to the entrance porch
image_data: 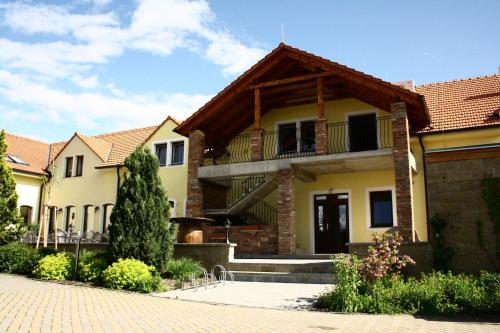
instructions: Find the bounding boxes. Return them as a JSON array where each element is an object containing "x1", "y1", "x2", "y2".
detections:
[{"x1": 227, "y1": 259, "x2": 332, "y2": 273}]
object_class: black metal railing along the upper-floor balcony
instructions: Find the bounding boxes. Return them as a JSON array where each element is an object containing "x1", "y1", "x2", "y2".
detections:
[{"x1": 204, "y1": 117, "x2": 392, "y2": 165}]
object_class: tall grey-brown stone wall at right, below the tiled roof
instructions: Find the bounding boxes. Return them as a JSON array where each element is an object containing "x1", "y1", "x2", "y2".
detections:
[{"x1": 427, "y1": 157, "x2": 500, "y2": 273}]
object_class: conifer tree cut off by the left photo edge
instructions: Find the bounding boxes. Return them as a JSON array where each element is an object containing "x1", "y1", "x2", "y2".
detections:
[{"x1": 0, "y1": 130, "x2": 23, "y2": 245}]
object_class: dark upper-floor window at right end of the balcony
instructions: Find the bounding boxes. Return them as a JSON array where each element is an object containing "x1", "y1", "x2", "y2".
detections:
[{"x1": 348, "y1": 113, "x2": 378, "y2": 151}]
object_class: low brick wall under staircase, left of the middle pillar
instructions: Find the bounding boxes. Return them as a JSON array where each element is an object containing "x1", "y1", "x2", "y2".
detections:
[{"x1": 202, "y1": 225, "x2": 278, "y2": 254}]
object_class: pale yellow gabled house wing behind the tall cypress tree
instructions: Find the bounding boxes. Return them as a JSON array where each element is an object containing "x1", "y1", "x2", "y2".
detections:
[{"x1": 40, "y1": 117, "x2": 186, "y2": 238}]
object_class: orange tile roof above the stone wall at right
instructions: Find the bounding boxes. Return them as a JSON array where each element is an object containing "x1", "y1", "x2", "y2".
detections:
[{"x1": 416, "y1": 74, "x2": 500, "y2": 133}]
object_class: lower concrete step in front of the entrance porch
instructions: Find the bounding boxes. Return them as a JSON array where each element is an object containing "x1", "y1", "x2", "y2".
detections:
[{"x1": 232, "y1": 271, "x2": 334, "y2": 284}]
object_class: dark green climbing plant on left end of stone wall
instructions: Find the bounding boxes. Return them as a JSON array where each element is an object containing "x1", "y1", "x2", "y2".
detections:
[{"x1": 429, "y1": 214, "x2": 455, "y2": 271}]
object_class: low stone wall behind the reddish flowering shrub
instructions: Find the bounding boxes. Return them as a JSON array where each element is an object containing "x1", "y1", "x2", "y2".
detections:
[{"x1": 349, "y1": 242, "x2": 432, "y2": 277}]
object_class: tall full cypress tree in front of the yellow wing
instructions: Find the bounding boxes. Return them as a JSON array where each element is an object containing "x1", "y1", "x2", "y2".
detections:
[{"x1": 109, "y1": 147, "x2": 175, "y2": 271}]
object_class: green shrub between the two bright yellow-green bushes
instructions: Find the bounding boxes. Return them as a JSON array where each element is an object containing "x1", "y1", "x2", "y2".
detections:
[{"x1": 78, "y1": 250, "x2": 109, "y2": 284}]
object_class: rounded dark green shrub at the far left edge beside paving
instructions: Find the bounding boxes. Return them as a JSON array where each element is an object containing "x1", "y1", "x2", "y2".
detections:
[{"x1": 0, "y1": 242, "x2": 40, "y2": 274}]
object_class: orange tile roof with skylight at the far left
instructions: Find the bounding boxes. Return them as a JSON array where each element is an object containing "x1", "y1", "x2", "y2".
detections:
[{"x1": 5, "y1": 133, "x2": 49, "y2": 175}]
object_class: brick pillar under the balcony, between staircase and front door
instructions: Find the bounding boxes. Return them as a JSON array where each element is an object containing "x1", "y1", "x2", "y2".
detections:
[{"x1": 278, "y1": 169, "x2": 295, "y2": 254}]
